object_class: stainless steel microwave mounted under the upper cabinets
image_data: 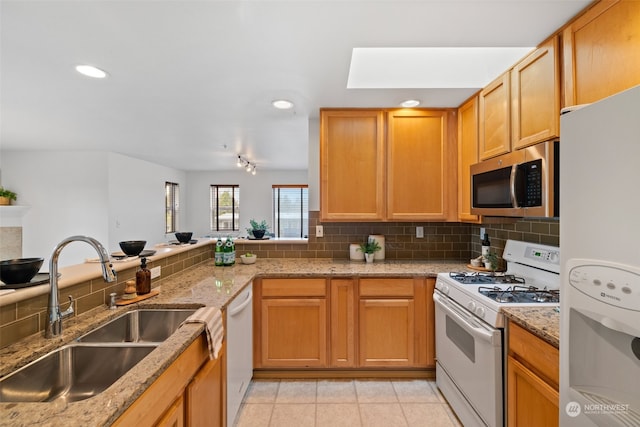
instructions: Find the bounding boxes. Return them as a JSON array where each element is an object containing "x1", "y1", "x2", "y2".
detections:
[{"x1": 471, "y1": 141, "x2": 560, "y2": 217}]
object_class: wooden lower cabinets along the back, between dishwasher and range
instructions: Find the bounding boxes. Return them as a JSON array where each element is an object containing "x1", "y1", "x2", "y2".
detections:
[{"x1": 254, "y1": 278, "x2": 435, "y2": 370}]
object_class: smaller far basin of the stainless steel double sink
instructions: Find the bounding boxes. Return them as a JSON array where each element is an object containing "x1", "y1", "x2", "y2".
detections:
[{"x1": 78, "y1": 309, "x2": 196, "y2": 343}]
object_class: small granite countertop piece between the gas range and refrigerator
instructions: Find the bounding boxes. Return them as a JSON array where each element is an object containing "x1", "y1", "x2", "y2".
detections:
[{"x1": 502, "y1": 307, "x2": 560, "y2": 348}]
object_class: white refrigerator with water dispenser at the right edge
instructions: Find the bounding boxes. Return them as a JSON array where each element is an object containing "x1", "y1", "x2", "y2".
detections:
[{"x1": 559, "y1": 86, "x2": 640, "y2": 427}]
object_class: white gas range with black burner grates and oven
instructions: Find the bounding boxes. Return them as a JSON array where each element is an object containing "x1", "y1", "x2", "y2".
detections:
[{"x1": 433, "y1": 240, "x2": 560, "y2": 427}]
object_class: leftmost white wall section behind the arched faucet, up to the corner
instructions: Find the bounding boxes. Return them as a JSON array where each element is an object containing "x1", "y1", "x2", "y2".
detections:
[{"x1": 0, "y1": 151, "x2": 109, "y2": 271}]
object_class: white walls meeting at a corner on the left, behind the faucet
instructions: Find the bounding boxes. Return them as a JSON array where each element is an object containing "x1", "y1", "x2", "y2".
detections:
[{"x1": 0, "y1": 151, "x2": 187, "y2": 271}]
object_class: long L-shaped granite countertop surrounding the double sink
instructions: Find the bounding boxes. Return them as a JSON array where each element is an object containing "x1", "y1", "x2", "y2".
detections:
[{"x1": 0, "y1": 259, "x2": 465, "y2": 426}]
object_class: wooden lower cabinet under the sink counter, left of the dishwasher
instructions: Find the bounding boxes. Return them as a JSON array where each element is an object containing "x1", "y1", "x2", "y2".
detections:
[{"x1": 113, "y1": 335, "x2": 226, "y2": 427}]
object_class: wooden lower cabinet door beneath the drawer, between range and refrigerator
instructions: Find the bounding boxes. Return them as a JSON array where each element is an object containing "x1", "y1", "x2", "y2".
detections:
[{"x1": 507, "y1": 356, "x2": 559, "y2": 427}]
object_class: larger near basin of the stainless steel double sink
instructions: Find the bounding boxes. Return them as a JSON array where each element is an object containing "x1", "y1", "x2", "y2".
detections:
[{"x1": 0, "y1": 344, "x2": 156, "y2": 402}]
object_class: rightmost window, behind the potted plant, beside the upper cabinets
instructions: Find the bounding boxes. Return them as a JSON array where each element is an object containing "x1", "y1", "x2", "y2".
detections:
[{"x1": 273, "y1": 185, "x2": 309, "y2": 237}]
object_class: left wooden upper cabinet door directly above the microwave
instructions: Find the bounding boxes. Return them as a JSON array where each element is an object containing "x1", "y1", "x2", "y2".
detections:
[{"x1": 479, "y1": 71, "x2": 511, "y2": 160}]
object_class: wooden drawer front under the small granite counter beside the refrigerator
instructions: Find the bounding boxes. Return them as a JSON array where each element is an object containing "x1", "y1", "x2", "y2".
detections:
[{"x1": 509, "y1": 322, "x2": 560, "y2": 388}]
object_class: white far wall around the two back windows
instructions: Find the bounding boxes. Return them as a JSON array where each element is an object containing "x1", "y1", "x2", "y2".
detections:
[{"x1": 183, "y1": 169, "x2": 308, "y2": 236}]
